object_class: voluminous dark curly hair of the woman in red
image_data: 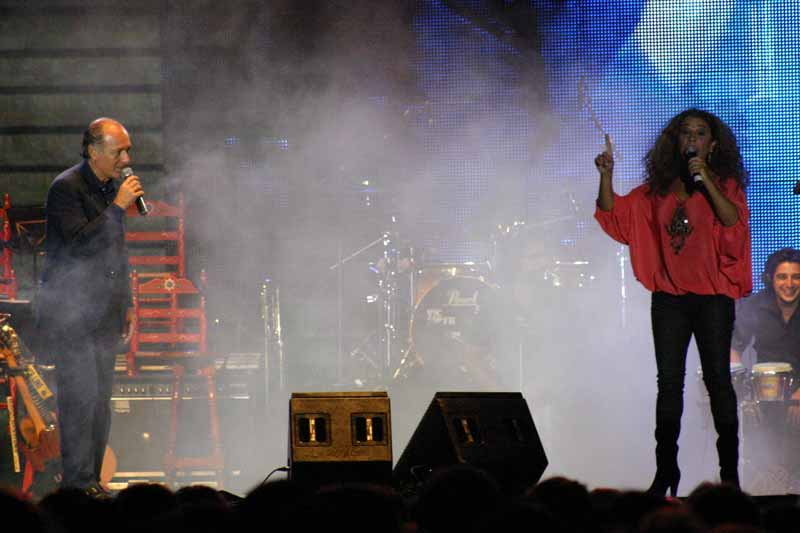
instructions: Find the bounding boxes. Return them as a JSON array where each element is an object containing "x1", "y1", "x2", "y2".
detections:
[{"x1": 644, "y1": 108, "x2": 749, "y2": 196}]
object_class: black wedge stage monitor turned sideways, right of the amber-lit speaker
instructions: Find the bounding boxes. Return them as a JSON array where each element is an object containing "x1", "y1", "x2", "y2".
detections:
[{"x1": 393, "y1": 392, "x2": 547, "y2": 494}]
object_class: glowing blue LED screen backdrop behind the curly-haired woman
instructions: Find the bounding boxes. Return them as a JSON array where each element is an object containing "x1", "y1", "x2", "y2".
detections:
[{"x1": 415, "y1": 0, "x2": 800, "y2": 288}]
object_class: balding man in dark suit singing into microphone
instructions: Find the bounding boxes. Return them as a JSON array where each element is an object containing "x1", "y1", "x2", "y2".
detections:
[{"x1": 36, "y1": 118, "x2": 143, "y2": 496}]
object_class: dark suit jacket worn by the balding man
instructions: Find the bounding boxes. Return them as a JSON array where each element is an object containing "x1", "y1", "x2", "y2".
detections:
[{"x1": 36, "y1": 161, "x2": 130, "y2": 353}]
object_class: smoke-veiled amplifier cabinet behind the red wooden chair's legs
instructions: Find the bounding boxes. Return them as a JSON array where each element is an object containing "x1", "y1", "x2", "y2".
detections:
[{"x1": 109, "y1": 371, "x2": 266, "y2": 490}]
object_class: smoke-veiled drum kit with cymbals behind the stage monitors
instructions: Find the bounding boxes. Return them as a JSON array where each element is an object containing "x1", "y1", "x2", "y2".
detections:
[{"x1": 345, "y1": 215, "x2": 595, "y2": 390}]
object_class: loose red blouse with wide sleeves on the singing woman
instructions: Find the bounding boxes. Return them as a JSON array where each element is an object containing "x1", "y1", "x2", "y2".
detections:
[{"x1": 594, "y1": 179, "x2": 753, "y2": 298}]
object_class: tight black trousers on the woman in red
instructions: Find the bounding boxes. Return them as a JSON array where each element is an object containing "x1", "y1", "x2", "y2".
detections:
[{"x1": 650, "y1": 292, "x2": 739, "y2": 472}]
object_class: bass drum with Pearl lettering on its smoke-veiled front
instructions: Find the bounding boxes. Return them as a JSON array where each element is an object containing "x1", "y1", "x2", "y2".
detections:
[{"x1": 394, "y1": 277, "x2": 500, "y2": 390}]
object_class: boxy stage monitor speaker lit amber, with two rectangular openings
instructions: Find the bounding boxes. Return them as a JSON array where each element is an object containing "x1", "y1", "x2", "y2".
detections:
[{"x1": 289, "y1": 392, "x2": 392, "y2": 486}]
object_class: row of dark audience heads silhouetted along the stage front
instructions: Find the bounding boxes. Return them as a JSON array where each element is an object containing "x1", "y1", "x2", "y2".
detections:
[{"x1": 0, "y1": 464, "x2": 800, "y2": 533}]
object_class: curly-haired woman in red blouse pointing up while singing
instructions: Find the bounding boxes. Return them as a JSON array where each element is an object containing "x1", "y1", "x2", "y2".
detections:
[{"x1": 595, "y1": 109, "x2": 752, "y2": 496}]
